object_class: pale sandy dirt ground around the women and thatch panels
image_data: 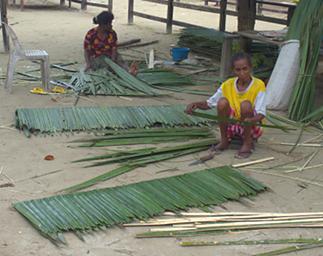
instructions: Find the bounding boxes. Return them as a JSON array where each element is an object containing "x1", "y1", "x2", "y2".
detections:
[{"x1": 0, "y1": 0, "x2": 323, "y2": 256}]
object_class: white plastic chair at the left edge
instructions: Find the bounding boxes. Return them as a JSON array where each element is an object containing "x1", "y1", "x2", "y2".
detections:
[{"x1": 2, "y1": 22, "x2": 49, "y2": 93}]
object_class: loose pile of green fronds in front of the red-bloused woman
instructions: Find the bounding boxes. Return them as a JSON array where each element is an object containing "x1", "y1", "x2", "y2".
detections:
[{"x1": 69, "y1": 58, "x2": 161, "y2": 96}]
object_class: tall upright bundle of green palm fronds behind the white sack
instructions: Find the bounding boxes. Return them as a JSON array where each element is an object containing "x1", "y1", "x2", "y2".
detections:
[{"x1": 288, "y1": 0, "x2": 323, "y2": 121}]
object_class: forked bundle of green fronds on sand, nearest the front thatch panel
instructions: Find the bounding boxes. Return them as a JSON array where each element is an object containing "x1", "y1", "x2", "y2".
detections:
[{"x1": 64, "y1": 138, "x2": 215, "y2": 192}]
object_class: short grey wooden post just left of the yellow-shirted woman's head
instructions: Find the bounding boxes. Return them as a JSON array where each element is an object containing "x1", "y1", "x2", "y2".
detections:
[{"x1": 220, "y1": 37, "x2": 233, "y2": 79}]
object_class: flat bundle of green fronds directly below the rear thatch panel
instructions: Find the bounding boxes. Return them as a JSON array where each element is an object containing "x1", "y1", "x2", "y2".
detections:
[{"x1": 73, "y1": 127, "x2": 213, "y2": 147}]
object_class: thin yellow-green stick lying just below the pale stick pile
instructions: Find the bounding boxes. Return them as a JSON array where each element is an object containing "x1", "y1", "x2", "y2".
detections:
[{"x1": 180, "y1": 238, "x2": 323, "y2": 247}]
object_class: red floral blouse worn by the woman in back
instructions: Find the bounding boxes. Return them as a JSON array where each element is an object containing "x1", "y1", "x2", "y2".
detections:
[{"x1": 83, "y1": 27, "x2": 118, "y2": 58}]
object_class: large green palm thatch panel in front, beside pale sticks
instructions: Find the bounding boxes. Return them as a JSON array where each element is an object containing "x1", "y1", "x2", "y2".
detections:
[{"x1": 13, "y1": 166, "x2": 266, "y2": 242}]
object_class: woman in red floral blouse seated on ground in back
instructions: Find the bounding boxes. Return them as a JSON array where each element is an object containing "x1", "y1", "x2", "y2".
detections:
[{"x1": 84, "y1": 11, "x2": 137, "y2": 74}]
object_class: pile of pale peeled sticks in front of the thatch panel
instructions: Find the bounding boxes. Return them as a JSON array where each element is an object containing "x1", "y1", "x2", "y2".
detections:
[{"x1": 131, "y1": 212, "x2": 323, "y2": 238}]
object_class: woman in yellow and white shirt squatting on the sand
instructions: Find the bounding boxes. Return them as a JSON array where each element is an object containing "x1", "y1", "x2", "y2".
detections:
[{"x1": 186, "y1": 53, "x2": 266, "y2": 158}]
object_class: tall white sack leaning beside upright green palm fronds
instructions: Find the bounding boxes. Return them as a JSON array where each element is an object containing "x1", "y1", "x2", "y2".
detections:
[{"x1": 266, "y1": 40, "x2": 299, "y2": 110}]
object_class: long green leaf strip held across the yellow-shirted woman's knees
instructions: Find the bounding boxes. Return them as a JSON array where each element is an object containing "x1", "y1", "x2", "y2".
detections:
[{"x1": 192, "y1": 111, "x2": 296, "y2": 131}]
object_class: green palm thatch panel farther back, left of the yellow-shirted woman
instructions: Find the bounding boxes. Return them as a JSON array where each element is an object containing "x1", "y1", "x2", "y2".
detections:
[{"x1": 16, "y1": 105, "x2": 207, "y2": 133}]
